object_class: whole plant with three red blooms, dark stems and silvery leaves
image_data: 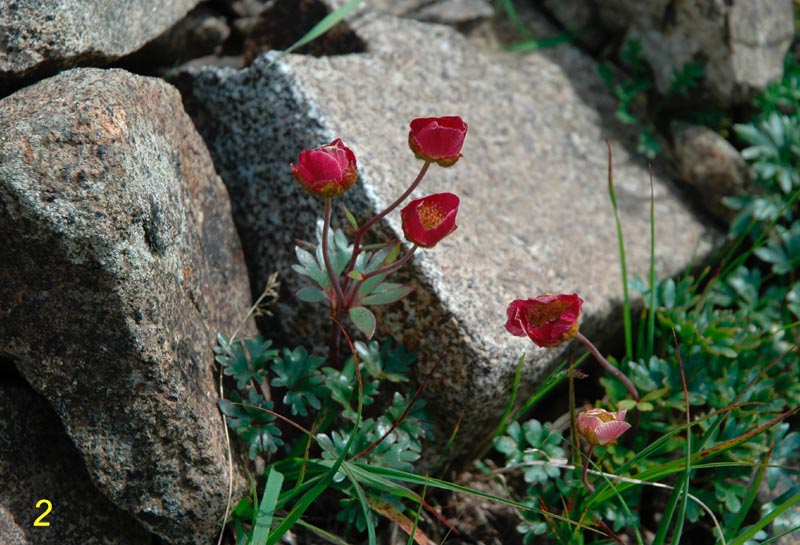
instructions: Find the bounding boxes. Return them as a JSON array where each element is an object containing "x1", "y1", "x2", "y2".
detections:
[{"x1": 291, "y1": 116, "x2": 467, "y2": 366}]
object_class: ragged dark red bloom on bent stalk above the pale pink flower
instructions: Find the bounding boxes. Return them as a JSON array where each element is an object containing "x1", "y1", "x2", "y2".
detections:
[{"x1": 506, "y1": 293, "x2": 583, "y2": 348}]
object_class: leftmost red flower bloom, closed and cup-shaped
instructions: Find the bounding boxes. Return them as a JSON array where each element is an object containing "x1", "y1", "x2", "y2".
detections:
[{"x1": 292, "y1": 138, "x2": 358, "y2": 199}]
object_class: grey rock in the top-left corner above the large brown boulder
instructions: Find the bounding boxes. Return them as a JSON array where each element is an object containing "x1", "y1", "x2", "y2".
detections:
[{"x1": 0, "y1": 0, "x2": 198, "y2": 86}]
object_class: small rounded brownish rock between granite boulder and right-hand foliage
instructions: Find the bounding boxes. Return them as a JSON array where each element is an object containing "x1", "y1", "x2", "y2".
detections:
[{"x1": 672, "y1": 124, "x2": 751, "y2": 221}]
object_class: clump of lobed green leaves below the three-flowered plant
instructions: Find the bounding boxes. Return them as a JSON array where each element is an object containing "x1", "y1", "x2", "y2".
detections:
[{"x1": 216, "y1": 335, "x2": 432, "y2": 542}]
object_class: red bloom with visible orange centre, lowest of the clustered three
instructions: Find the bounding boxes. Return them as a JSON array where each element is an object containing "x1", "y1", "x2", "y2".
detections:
[{"x1": 400, "y1": 193, "x2": 459, "y2": 248}]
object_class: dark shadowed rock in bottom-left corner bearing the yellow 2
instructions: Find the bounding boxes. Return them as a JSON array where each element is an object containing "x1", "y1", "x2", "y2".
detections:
[{"x1": 0, "y1": 385, "x2": 153, "y2": 545}]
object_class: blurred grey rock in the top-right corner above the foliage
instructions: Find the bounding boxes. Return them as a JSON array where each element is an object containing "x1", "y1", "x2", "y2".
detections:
[{"x1": 595, "y1": 0, "x2": 794, "y2": 107}]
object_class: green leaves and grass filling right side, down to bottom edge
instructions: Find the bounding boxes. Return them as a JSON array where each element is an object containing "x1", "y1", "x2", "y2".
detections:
[{"x1": 495, "y1": 50, "x2": 800, "y2": 545}]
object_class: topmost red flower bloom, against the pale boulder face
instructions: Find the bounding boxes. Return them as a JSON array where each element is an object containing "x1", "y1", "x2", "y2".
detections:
[{"x1": 408, "y1": 116, "x2": 467, "y2": 167}]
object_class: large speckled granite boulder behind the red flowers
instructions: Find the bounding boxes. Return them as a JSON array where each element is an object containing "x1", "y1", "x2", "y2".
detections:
[{"x1": 179, "y1": 13, "x2": 714, "y2": 462}]
